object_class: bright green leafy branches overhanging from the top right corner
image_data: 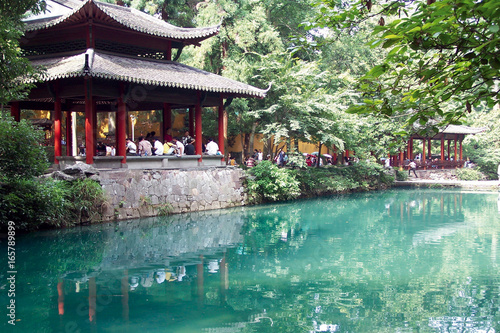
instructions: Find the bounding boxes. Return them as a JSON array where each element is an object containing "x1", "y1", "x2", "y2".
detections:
[{"x1": 316, "y1": 0, "x2": 500, "y2": 124}]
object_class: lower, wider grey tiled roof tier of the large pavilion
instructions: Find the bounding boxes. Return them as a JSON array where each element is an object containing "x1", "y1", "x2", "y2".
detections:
[{"x1": 27, "y1": 49, "x2": 267, "y2": 98}]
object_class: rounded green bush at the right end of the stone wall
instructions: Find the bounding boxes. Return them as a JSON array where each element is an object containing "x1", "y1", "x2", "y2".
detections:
[{"x1": 247, "y1": 161, "x2": 300, "y2": 203}]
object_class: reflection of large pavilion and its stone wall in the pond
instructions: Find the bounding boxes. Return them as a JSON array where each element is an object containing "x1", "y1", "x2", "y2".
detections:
[{"x1": 57, "y1": 212, "x2": 244, "y2": 324}]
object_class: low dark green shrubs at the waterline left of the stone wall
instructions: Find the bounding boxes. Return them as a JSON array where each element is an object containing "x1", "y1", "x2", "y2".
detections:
[{"x1": 0, "y1": 178, "x2": 105, "y2": 231}]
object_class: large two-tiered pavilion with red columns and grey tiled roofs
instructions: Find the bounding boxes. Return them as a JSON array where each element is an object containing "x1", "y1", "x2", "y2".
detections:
[{"x1": 9, "y1": 0, "x2": 267, "y2": 167}]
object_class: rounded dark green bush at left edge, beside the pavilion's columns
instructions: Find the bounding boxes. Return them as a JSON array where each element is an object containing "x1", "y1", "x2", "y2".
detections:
[{"x1": 0, "y1": 115, "x2": 49, "y2": 179}]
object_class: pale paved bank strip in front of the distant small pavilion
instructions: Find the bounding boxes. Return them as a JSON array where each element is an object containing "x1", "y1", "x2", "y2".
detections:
[{"x1": 395, "y1": 177, "x2": 500, "y2": 191}]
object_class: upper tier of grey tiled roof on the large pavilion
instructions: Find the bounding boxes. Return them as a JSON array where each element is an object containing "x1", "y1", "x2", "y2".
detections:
[{"x1": 25, "y1": 0, "x2": 220, "y2": 40}]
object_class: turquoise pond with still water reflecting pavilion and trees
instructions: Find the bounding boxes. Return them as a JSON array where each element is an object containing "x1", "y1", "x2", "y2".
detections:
[{"x1": 0, "y1": 189, "x2": 500, "y2": 333}]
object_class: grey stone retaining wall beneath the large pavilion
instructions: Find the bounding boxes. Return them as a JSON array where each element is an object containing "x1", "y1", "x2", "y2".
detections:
[{"x1": 99, "y1": 167, "x2": 247, "y2": 221}]
